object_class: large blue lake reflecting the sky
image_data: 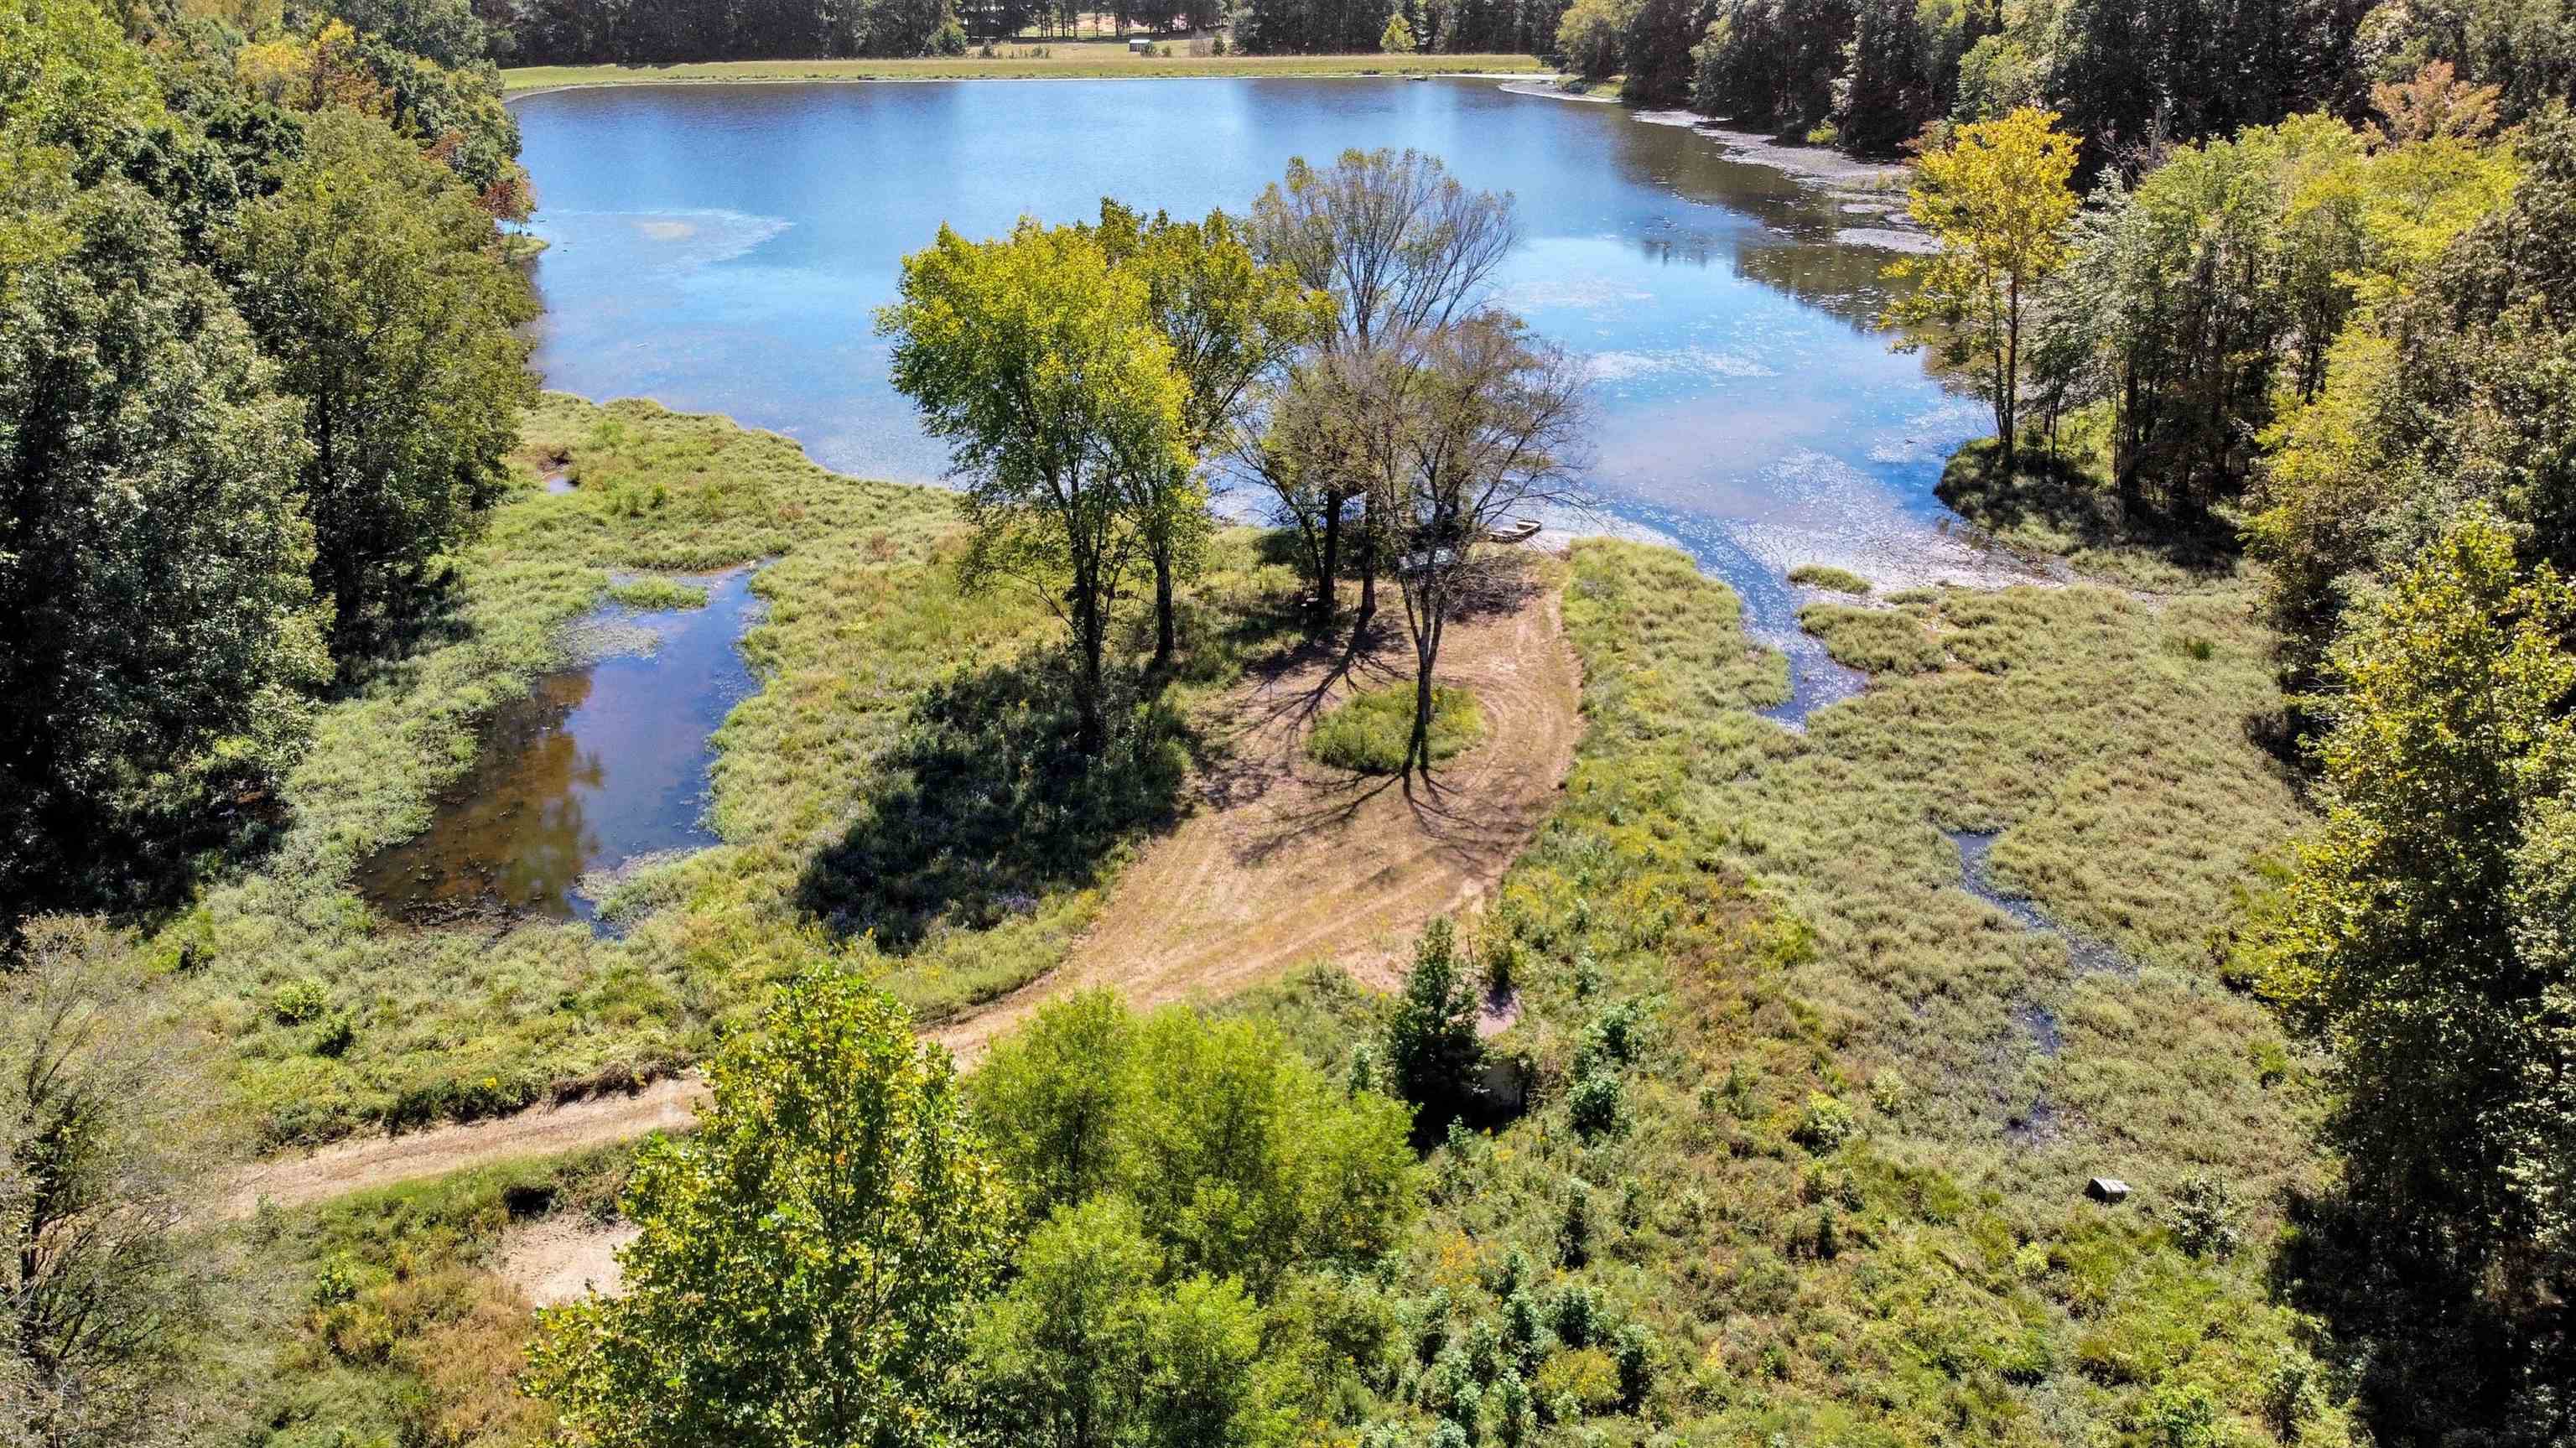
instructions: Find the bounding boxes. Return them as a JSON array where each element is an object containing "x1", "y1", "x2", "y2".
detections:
[{"x1": 515, "y1": 80, "x2": 1992, "y2": 719}]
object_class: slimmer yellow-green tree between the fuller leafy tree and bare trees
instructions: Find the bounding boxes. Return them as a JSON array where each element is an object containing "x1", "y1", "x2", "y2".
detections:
[{"x1": 1100, "y1": 201, "x2": 1332, "y2": 667}]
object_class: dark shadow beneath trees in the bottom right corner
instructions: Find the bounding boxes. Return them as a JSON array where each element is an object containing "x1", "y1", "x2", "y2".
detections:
[{"x1": 2272, "y1": 1193, "x2": 2576, "y2": 1445}]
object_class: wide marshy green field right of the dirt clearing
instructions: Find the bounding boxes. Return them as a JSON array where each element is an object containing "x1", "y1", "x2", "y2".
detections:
[{"x1": 1329, "y1": 543, "x2": 2345, "y2": 1445}]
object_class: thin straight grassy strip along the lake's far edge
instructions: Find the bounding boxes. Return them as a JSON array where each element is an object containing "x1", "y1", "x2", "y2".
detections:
[{"x1": 500, "y1": 41, "x2": 1548, "y2": 96}]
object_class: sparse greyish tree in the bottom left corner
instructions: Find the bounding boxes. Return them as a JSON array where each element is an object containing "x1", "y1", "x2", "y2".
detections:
[{"x1": 0, "y1": 920, "x2": 219, "y2": 1448}]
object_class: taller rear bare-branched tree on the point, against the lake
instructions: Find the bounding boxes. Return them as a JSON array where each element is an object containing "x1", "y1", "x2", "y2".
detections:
[{"x1": 1252, "y1": 149, "x2": 1519, "y2": 629}]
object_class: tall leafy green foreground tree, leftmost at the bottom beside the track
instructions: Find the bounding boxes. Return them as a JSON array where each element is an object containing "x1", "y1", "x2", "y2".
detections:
[{"x1": 528, "y1": 966, "x2": 1007, "y2": 1448}]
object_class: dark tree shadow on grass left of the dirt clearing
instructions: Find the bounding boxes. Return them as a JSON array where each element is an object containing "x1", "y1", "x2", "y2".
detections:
[{"x1": 796, "y1": 651, "x2": 1201, "y2": 953}]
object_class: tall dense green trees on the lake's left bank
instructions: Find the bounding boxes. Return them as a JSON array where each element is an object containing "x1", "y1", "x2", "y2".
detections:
[{"x1": 0, "y1": 0, "x2": 531, "y2": 920}]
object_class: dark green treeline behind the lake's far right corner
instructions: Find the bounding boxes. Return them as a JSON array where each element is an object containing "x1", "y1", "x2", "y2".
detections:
[{"x1": 1553, "y1": 0, "x2": 2576, "y2": 163}]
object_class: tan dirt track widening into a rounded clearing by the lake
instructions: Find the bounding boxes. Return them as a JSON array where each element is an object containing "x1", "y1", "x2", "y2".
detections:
[{"x1": 224, "y1": 569, "x2": 1581, "y2": 1211}]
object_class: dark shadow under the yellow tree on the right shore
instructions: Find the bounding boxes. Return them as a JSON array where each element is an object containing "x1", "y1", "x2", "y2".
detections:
[{"x1": 1932, "y1": 438, "x2": 2241, "y2": 582}]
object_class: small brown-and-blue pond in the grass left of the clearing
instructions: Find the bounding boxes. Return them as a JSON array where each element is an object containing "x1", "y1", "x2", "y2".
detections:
[{"x1": 358, "y1": 569, "x2": 760, "y2": 922}]
